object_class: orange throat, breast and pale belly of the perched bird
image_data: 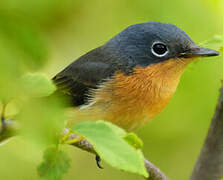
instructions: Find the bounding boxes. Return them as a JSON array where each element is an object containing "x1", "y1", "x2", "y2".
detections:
[{"x1": 77, "y1": 59, "x2": 191, "y2": 131}]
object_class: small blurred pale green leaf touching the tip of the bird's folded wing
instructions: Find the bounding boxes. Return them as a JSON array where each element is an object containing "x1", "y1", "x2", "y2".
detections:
[{"x1": 22, "y1": 73, "x2": 56, "y2": 97}]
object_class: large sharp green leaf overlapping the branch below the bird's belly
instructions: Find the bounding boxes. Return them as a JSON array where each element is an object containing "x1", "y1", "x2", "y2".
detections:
[{"x1": 72, "y1": 121, "x2": 148, "y2": 177}]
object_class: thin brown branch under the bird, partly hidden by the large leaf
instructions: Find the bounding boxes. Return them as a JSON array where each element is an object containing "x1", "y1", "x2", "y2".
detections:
[{"x1": 64, "y1": 129, "x2": 169, "y2": 180}]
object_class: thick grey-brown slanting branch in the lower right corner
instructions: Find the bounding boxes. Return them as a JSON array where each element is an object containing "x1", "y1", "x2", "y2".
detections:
[{"x1": 190, "y1": 86, "x2": 223, "y2": 180}]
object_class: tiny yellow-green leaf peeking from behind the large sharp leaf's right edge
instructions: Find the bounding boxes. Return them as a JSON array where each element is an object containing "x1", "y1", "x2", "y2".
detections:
[{"x1": 124, "y1": 133, "x2": 143, "y2": 149}]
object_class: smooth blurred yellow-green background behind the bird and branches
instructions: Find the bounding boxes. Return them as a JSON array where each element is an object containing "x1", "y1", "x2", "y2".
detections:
[{"x1": 0, "y1": 0, "x2": 223, "y2": 180}]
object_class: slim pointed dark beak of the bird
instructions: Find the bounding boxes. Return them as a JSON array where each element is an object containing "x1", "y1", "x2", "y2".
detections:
[{"x1": 180, "y1": 46, "x2": 220, "y2": 58}]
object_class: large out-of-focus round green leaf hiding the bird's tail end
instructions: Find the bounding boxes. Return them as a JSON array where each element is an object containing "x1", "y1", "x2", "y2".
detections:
[{"x1": 16, "y1": 97, "x2": 66, "y2": 147}]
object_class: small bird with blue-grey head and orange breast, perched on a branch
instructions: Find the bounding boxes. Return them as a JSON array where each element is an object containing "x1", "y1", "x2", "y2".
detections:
[{"x1": 53, "y1": 22, "x2": 219, "y2": 131}]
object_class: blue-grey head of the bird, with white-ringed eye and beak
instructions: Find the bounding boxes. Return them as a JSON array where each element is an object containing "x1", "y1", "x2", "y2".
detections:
[{"x1": 104, "y1": 22, "x2": 219, "y2": 66}]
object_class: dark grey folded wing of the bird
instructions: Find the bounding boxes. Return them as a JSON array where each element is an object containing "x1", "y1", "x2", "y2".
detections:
[{"x1": 53, "y1": 49, "x2": 115, "y2": 106}]
